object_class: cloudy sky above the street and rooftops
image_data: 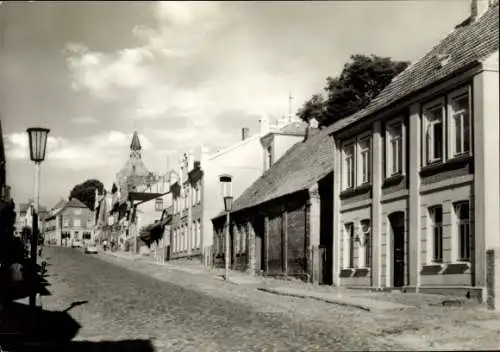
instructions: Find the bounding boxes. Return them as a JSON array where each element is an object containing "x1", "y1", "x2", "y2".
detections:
[{"x1": 0, "y1": 0, "x2": 470, "y2": 207}]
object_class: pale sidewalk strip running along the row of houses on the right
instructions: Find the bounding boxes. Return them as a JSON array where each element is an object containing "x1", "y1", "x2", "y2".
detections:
[{"x1": 101, "y1": 252, "x2": 484, "y2": 312}]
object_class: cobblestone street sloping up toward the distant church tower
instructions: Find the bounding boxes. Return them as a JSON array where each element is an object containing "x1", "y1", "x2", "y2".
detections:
[{"x1": 24, "y1": 248, "x2": 496, "y2": 351}]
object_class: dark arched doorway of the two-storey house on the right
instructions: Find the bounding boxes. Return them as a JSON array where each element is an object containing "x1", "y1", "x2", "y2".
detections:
[{"x1": 389, "y1": 211, "x2": 406, "y2": 287}]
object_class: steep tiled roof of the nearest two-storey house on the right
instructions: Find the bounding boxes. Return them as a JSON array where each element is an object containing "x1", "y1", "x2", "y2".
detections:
[{"x1": 329, "y1": 2, "x2": 499, "y2": 133}]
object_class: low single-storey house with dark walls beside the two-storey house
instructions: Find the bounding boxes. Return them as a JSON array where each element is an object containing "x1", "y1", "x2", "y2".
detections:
[{"x1": 212, "y1": 123, "x2": 333, "y2": 283}]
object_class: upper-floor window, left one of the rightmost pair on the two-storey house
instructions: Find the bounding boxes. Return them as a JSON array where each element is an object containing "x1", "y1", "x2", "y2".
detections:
[{"x1": 425, "y1": 103, "x2": 444, "y2": 164}]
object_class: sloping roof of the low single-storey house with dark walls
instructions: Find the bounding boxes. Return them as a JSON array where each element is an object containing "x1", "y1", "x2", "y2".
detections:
[{"x1": 221, "y1": 129, "x2": 333, "y2": 216}]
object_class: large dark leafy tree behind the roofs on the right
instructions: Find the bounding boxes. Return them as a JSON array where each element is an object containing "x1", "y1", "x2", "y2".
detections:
[{"x1": 297, "y1": 54, "x2": 409, "y2": 126}]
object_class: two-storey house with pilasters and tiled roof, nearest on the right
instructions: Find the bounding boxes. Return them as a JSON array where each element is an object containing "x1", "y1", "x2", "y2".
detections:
[{"x1": 329, "y1": 0, "x2": 500, "y2": 296}]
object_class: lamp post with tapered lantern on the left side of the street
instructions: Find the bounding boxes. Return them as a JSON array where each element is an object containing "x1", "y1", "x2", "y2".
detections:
[{"x1": 26, "y1": 127, "x2": 50, "y2": 307}]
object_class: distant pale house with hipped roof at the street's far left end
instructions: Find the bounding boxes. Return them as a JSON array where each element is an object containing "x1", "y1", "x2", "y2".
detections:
[{"x1": 44, "y1": 198, "x2": 95, "y2": 247}]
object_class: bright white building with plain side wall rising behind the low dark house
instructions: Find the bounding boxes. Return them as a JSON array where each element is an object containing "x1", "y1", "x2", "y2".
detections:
[{"x1": 171, "y1": 117, "x2": 306, "y2": 265}]
